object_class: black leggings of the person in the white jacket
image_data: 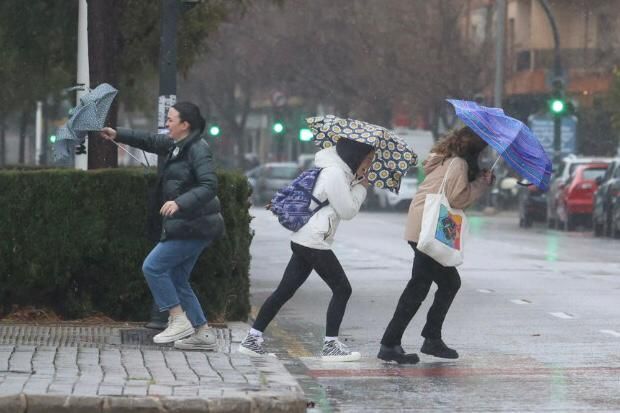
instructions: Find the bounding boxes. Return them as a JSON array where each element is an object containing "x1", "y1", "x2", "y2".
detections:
[{"x1": 252, "y1": 242, "x2": 351, "y2": 337}]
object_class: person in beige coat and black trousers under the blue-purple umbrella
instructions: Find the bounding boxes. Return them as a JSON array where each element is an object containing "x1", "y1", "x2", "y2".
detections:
[{"x1": 377, "y1": 127, "x2": 493, "y2": 364}]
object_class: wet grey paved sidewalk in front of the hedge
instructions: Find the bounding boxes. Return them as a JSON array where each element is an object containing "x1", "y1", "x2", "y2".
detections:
[{"x1": 0, "y1": 323, "x2": 306, "y2": 413}]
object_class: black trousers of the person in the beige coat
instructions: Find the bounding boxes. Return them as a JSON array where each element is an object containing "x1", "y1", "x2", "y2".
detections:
[{"x1": 381, "y1": 242, "x2": 461, "y2": 347}]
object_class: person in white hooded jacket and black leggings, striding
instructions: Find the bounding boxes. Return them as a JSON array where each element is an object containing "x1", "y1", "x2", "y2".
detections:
[{"x1": 239, "y1": 138, "x2": 374, "y2": 361}]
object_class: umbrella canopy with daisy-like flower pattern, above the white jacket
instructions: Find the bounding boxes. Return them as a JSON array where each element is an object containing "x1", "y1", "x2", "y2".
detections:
[{"x1": 306, "y1": 115, "x2": 418, "y2": 193}]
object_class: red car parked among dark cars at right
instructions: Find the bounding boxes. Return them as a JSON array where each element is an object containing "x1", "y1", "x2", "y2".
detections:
[{"x1": 557, "y1": 162, "x2": 609, "y2": 231}]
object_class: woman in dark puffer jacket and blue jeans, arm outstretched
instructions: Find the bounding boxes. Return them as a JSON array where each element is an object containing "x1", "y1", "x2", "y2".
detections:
[{"x1": 101, "y1": 102, "x2": 224, "y2": 350}]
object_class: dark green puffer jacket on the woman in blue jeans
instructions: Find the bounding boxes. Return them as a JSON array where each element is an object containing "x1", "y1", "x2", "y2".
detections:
[{"x1": 116, "y1": 128, "x2": 224, "y2": 241}]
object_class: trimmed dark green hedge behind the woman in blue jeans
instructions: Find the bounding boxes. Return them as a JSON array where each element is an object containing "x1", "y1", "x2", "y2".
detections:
[{"x1": 0, "y1": 168, "x2": 252, "y2": 321}]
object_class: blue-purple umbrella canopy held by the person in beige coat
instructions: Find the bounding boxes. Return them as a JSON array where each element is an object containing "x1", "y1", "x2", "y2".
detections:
[{"x1": 448, "y1": 99, "x2": 551, "y2": 191}]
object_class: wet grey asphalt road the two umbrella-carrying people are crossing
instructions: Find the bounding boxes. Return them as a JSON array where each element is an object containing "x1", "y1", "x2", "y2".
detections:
[{"x1": 251, "y1": 209, "x2": 620, "y2": 412}]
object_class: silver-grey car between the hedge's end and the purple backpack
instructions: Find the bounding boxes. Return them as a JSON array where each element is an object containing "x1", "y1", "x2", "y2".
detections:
[{"x1": 245, "y1": 162, "x2": 301, "y2": 205}]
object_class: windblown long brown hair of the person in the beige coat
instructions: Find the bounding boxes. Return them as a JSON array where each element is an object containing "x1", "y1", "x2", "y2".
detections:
[{"x1": 431, "y1": 126, "x2": 487, "y2": 182}]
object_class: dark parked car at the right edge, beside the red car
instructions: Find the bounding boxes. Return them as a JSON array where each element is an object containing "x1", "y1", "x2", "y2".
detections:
[{"x1": 592, "y1": 159, "x2": 620, "y2": 237}]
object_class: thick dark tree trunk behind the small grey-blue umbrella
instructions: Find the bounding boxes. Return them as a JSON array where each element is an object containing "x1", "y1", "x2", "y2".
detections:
[{"x1": 88, "y1": 0, "x2": 123, "y2": 169}]
